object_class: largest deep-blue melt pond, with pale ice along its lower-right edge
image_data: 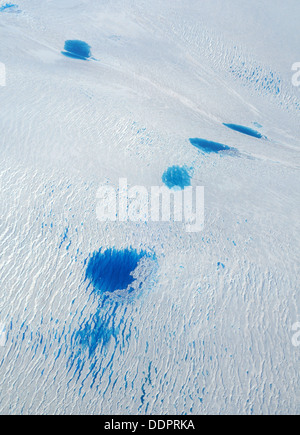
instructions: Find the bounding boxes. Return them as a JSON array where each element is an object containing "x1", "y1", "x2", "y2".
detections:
[{"x1": 86, "y1": 249, "x2": 149, "y2": 293}]
